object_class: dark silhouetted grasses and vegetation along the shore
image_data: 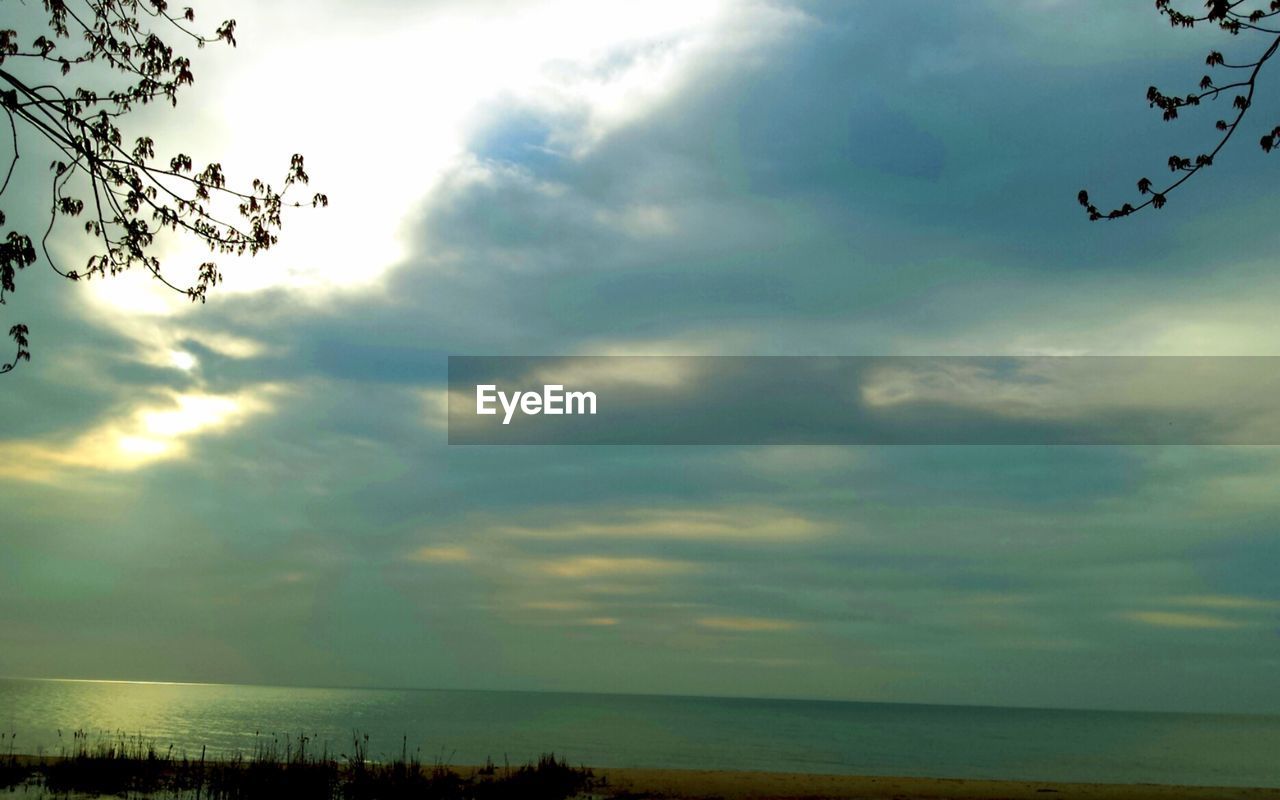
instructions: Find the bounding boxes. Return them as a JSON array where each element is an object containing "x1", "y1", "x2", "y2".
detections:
[{"x1": 0, "y1": 732, "x2": 596, "y2": 800}]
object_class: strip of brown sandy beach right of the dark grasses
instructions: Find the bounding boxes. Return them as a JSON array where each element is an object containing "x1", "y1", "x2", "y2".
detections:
[{"x1": 595, "y1": 769, "x2": 1280, "y2": 800}]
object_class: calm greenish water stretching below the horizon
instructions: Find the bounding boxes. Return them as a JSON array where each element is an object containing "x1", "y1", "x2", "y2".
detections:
[{"x1": 0, "y1": 680, "x2": 1280, "y2": 786}]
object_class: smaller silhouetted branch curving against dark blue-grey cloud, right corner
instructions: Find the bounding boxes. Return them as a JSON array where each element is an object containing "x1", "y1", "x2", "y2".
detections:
[{"x1": 1078, "y1": 0, "x2": 1280, "y2": 220}]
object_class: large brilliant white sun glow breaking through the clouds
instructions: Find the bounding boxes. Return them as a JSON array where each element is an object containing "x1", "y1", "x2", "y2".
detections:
[{"x1": 77, "y1": 0, "x2": 747, "y2": 327}]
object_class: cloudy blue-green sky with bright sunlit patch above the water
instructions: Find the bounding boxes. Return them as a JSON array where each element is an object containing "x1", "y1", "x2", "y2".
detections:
[{"x1": 0, "y1": 0, "x2": 1280, "y2": 713}]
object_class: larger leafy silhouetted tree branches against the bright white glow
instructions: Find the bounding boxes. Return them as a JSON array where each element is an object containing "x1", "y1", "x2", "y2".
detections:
[{"x1": 0, "y1": 0, "x2": 329, "y2": 374}]
